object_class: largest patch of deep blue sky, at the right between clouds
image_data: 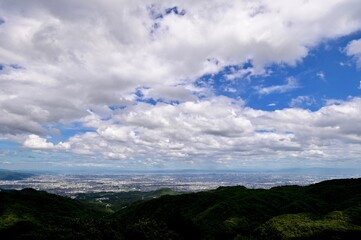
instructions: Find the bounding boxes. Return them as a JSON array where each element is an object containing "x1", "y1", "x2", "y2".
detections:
[{"x1": 197, "y1": 32, "x2": 361, "y2": 111}]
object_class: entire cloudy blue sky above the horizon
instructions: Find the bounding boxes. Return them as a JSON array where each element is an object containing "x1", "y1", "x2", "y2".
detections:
[{"x1": 0, "y1": 0, "x2": 361, "y2": 171}]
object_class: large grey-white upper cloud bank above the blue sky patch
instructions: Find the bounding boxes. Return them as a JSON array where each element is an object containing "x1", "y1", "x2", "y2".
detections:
[{"x1": 0, "y1": 0, "x2": 361, "y2": 137}]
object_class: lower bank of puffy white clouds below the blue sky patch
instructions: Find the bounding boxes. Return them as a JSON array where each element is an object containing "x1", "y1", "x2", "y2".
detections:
[{"x1": 24, "y1": 97, "x2": 361, "y2": 166}]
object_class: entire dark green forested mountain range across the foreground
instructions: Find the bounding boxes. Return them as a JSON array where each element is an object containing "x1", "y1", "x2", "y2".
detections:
[{"x1": 0, "y1": 179, "x2": 361, "y2": 240}]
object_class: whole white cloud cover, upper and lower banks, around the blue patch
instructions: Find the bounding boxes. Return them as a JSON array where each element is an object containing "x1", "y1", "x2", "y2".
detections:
[{"x1": 0, "y1": 0, "x2": 361, "y2": 167}]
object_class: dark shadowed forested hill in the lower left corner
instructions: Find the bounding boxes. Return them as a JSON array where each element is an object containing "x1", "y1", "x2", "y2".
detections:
[{"x1": 0, "y1": 189, "x2": 121, "y2": 239}]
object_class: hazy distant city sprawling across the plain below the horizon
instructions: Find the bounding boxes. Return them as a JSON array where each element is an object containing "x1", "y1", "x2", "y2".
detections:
[{"x1": 0, "y1": 172, "x2": 361, "y2": 197}]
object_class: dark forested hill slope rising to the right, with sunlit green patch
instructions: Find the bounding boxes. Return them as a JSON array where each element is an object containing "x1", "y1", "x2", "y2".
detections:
[{"x1": 115, "y1": 179, "x2": 361, "y2": 239}]
